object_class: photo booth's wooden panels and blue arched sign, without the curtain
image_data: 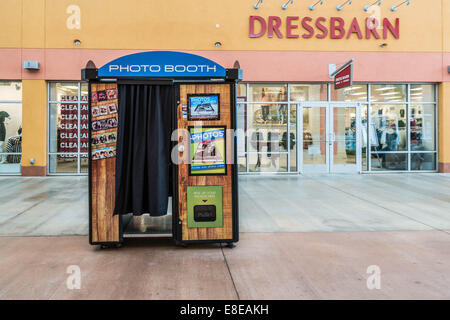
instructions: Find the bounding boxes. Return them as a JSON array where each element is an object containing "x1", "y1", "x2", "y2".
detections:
[{"x1": 82, "y1": 51, "x2": 242, "y2": 246}]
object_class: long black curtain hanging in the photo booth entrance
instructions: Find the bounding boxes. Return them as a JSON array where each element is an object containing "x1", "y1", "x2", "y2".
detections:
[{"x1": 114, "y1": 84, "x2": 173, "y2": 216}]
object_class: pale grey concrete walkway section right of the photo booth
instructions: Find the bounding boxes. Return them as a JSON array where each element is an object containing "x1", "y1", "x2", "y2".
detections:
[{"x1": 239, "y1": 173, "x2": 450, "y2": 232}]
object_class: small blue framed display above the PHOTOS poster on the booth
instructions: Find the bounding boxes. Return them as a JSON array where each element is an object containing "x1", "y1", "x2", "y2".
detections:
[{"x1": 188, "y1": 94, "x2": 220, "y2": 120}]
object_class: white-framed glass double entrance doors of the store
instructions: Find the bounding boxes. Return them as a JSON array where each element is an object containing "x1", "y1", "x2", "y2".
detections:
[{"x1": 299, "y1": 102, "x2": 361, "y2": 173}]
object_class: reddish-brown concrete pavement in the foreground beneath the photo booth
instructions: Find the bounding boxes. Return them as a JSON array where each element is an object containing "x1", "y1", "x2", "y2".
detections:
[{"x1": 0, "y1": 231, "x2": 450, "y2": 299}]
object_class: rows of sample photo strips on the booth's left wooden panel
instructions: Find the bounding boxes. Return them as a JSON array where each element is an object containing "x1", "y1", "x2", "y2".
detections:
[{"x1": 90, "y1": 87, "x2": 118, "y2": 160}]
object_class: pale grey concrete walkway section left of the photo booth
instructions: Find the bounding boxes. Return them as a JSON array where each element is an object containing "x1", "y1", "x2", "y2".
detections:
[{"x1": 0, "y1": 176, "x2": 89, "y2": 236}]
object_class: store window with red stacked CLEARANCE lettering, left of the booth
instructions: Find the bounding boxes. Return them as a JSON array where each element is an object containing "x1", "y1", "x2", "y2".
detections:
[{"x1": 48, "y1": 82, "x2": 88, "y2": 174}]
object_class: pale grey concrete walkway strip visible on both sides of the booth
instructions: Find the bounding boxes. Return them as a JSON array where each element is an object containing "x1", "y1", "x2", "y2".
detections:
[{"x1": 0, "y1": 173, "x2": 450, "y2": 236}]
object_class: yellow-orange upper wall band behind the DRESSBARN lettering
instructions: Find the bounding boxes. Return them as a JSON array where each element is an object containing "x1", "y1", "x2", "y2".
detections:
[{"x1": 0, "y1": 0, "x2": 450, "y2": 52}]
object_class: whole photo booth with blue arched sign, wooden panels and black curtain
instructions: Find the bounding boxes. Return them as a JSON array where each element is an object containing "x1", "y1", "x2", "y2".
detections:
[{"x1": 81, "y1": 51, "x2": 242, "y2": 247}]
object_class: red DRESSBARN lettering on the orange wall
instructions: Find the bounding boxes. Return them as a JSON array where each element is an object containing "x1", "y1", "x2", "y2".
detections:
[{"x1": 249, "y1": 16, "x2": 400, "y2": 39}]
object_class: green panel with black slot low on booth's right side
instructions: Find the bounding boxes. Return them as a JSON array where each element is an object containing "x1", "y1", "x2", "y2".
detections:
[{"x1": 187, "y1": 186, "x2": 223, "y2": 228}]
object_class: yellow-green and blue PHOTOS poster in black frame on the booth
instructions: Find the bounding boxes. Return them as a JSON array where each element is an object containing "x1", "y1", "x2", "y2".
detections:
[{"x1": 189, "y1": 127, "x2": 226, "y2": 175}]
